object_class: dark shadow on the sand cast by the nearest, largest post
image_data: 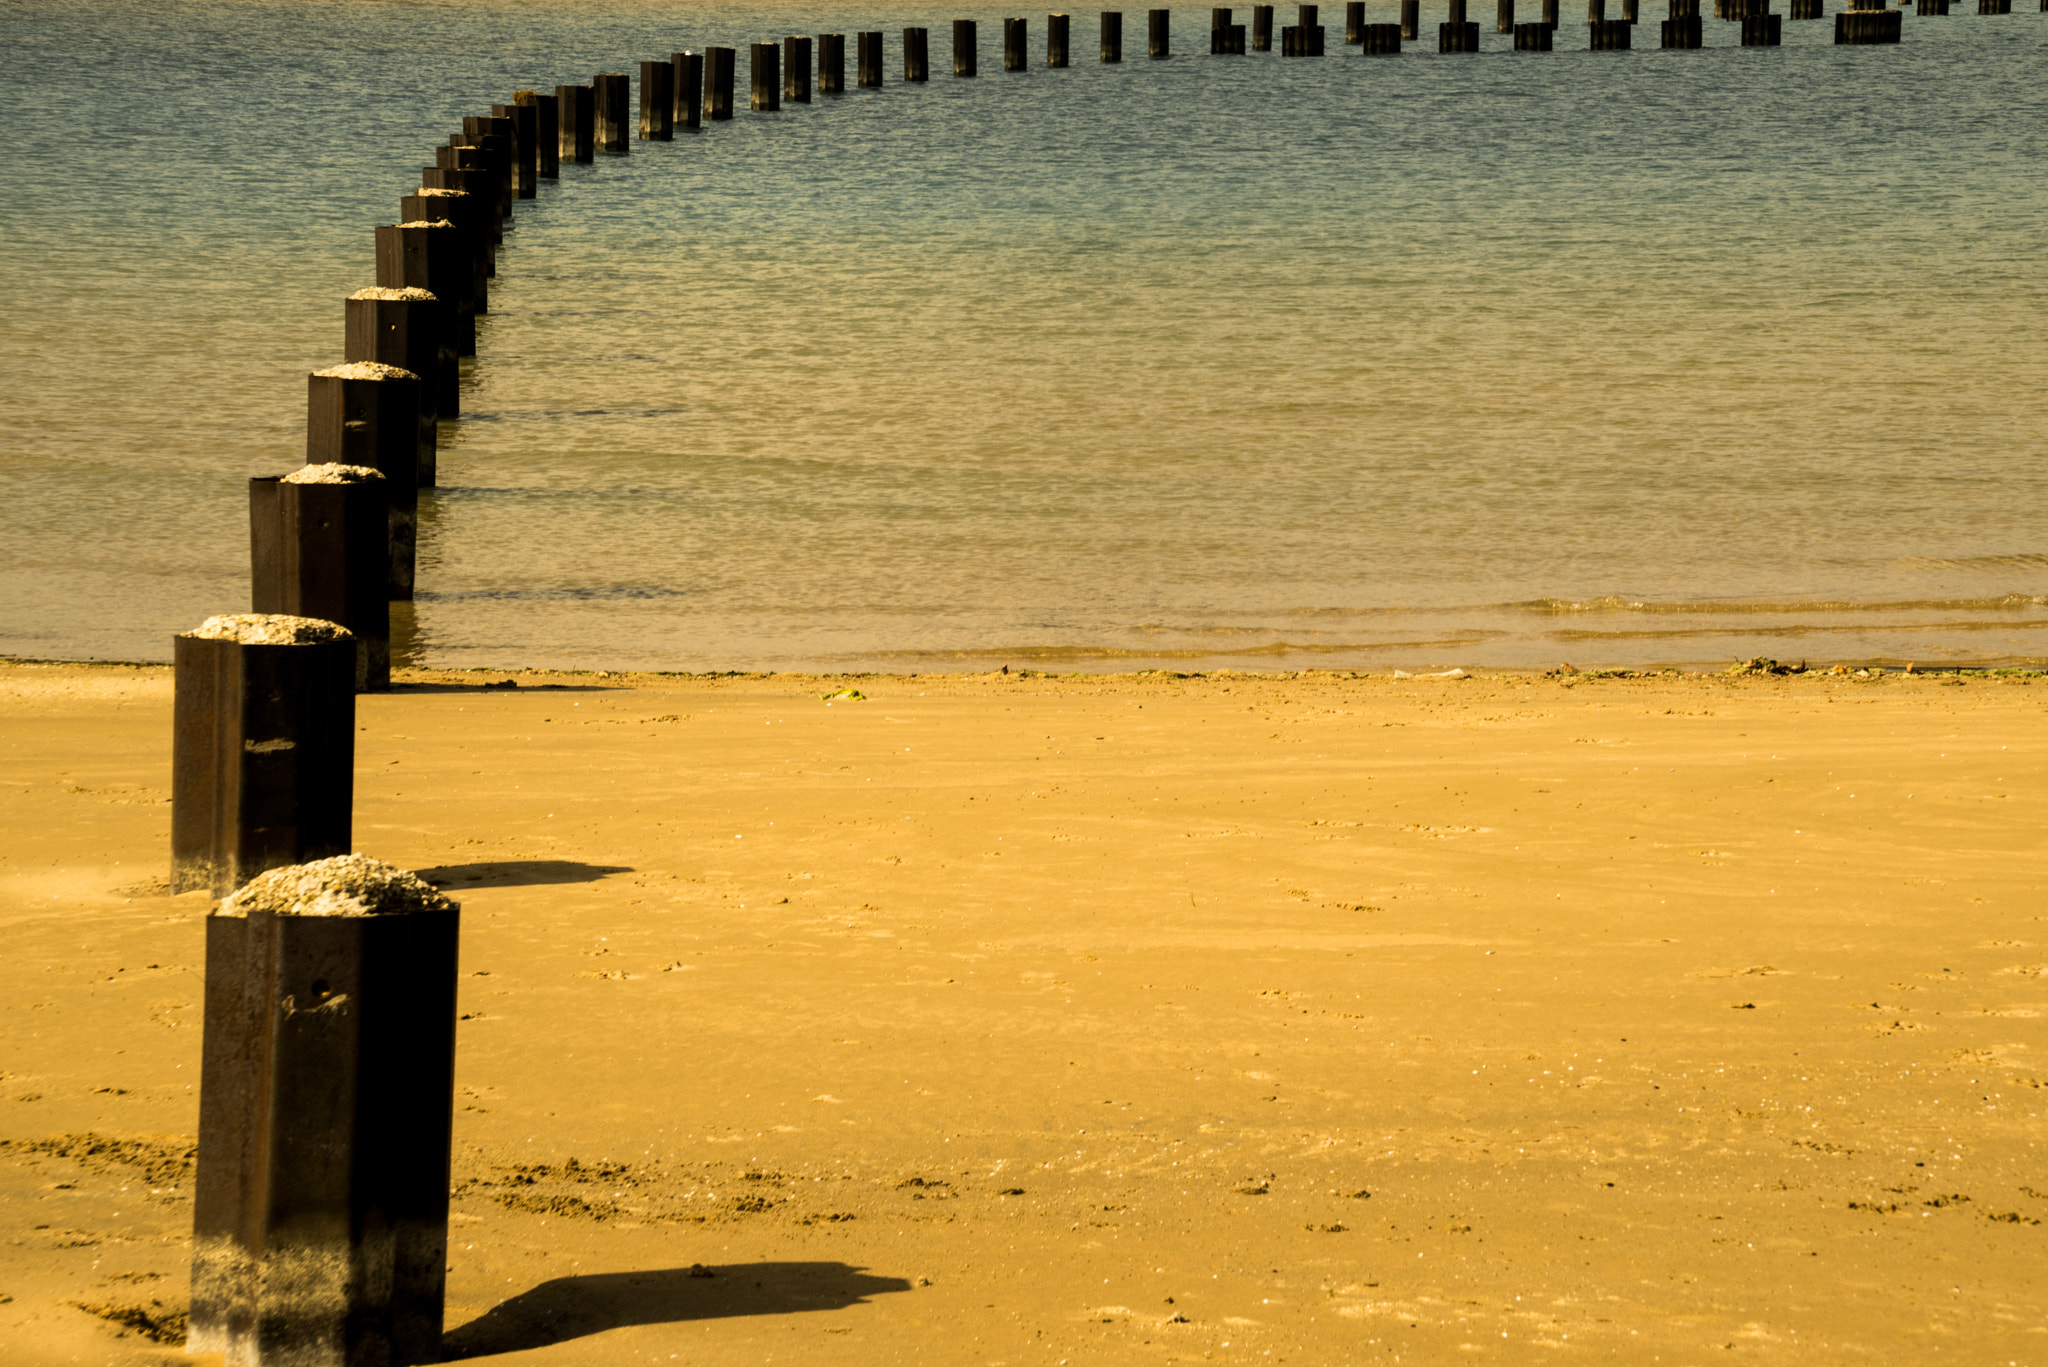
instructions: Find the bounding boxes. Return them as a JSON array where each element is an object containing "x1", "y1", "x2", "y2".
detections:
[{"x1": 440, "y1": 1262, "x2": 909, "y2": 1363}]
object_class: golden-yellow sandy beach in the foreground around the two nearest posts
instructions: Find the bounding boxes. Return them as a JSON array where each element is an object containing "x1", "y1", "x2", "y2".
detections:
[{"x1": 0, "y1": 664, "x2": 2048, "y2": 1367}]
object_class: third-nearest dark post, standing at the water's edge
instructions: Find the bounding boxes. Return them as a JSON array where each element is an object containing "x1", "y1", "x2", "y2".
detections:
[{"x1": 250, "y1": 465, "x2": 391, "y2": 693}]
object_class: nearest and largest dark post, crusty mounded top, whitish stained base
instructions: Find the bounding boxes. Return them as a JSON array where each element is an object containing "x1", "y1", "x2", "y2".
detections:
[{"x1": 186, "y1": 856, "x2": 459, "y2": 1367}]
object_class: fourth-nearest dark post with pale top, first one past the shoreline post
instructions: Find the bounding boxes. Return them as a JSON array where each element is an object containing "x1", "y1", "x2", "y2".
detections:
[{"x1": 305, "y1": 361, "x2": 420, "y2": 598}]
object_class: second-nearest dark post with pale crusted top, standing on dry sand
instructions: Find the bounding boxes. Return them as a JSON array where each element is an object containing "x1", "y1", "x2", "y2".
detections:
[{"x1": 170, "y1": 615, "x2": 356, "y2": 897}]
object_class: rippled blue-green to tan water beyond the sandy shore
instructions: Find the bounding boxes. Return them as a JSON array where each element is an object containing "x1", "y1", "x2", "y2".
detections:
[{"x1": 0, "y1": 0, "x2": 2048, "y2": 668}]
